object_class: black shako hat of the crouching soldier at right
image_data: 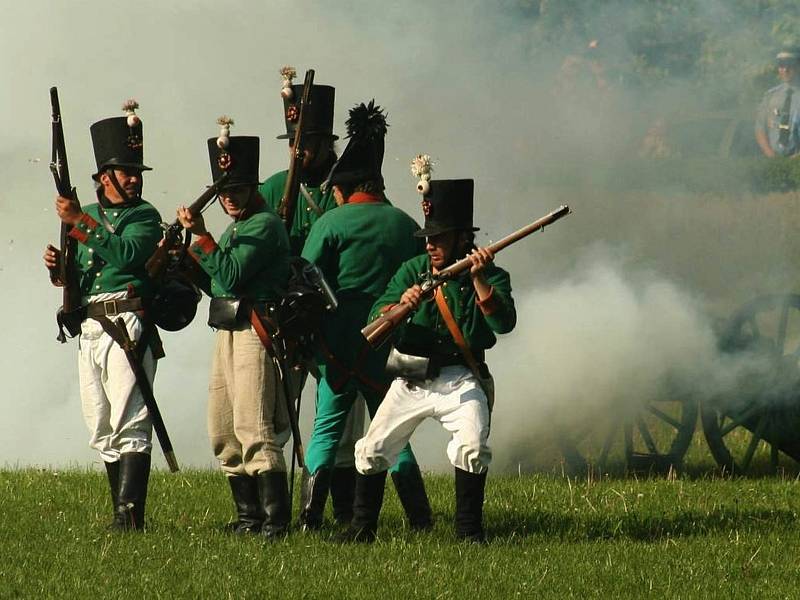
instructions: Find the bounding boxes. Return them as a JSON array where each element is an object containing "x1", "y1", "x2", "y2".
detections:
[{"x1": 414, "y1": 179, "x2": 478, "y2": 237}]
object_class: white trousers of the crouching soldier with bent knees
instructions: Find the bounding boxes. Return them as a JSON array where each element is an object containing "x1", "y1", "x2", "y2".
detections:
[{"x1": 355, "y1": 366, "x2": 492, "y2": 475}]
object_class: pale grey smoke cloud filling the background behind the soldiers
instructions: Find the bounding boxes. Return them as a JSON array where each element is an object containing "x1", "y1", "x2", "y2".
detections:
[{"x1": 0, "y1": 0, "x2": 800, "y2": 469}]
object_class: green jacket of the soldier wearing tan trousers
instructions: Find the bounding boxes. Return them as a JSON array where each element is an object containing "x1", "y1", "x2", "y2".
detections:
[{"x1": 189, "y1": 199, "x2": 289, "y2": 302}]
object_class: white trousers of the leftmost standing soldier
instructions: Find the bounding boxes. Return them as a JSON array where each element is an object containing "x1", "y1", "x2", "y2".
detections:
[{"x1": 78, "y1": 293, "x2": 156, "y2": 462}]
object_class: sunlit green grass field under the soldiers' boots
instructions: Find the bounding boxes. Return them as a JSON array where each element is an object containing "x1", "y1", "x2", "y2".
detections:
[{"x1": 0, "y1": 470, "x2": 800, "y2": 599}]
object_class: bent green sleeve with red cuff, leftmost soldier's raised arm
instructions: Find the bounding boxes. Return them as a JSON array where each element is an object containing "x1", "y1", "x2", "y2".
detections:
[{"x1": 70, "y1": 205, "x2": 163, "y2": 269}]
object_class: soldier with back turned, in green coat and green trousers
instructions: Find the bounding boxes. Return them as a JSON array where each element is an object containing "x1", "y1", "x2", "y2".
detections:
[{"x1": 300, "y1": 102, "x2": 431, "y2": 529}]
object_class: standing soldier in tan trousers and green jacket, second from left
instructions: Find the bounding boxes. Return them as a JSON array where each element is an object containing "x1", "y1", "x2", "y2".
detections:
[{"x1": 178, "y1": 118, "x2": 291, "y2": 538}]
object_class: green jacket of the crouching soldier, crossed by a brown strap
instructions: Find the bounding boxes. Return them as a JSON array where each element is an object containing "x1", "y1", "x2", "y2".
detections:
[{"x1": 370, "y1": 254, "x2": 517, "y2": 356}]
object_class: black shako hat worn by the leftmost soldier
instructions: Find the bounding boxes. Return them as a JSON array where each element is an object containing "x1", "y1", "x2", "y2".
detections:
[{"x1": 89, "y1": 117, "x2": 152, "y2": 180}]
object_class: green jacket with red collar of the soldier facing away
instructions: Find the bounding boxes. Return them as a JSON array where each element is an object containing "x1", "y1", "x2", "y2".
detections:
[{"x1": 303, "y1": 202, "x2": 423, "y2": 389}]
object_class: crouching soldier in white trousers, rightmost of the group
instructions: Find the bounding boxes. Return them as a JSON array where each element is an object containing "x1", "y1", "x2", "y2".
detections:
[{"x1": 349, "y1": 165, "x2": 516, "y2": 542}]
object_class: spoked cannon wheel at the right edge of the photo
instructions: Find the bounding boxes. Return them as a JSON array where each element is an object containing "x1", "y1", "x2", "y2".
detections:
[{"x1": 700, "y1": 294, "x2": 800, "y2": 474}]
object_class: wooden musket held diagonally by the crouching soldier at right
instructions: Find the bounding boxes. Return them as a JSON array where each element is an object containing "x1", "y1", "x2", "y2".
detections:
[{"x1": 361, "y1": 205, "x2": 570, "y2": 348}]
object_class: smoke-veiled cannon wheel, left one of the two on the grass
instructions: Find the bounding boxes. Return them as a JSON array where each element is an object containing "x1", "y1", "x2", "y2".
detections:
[{"x1": 559, "y1": 399, "x2": 698, "y2": 475}]
